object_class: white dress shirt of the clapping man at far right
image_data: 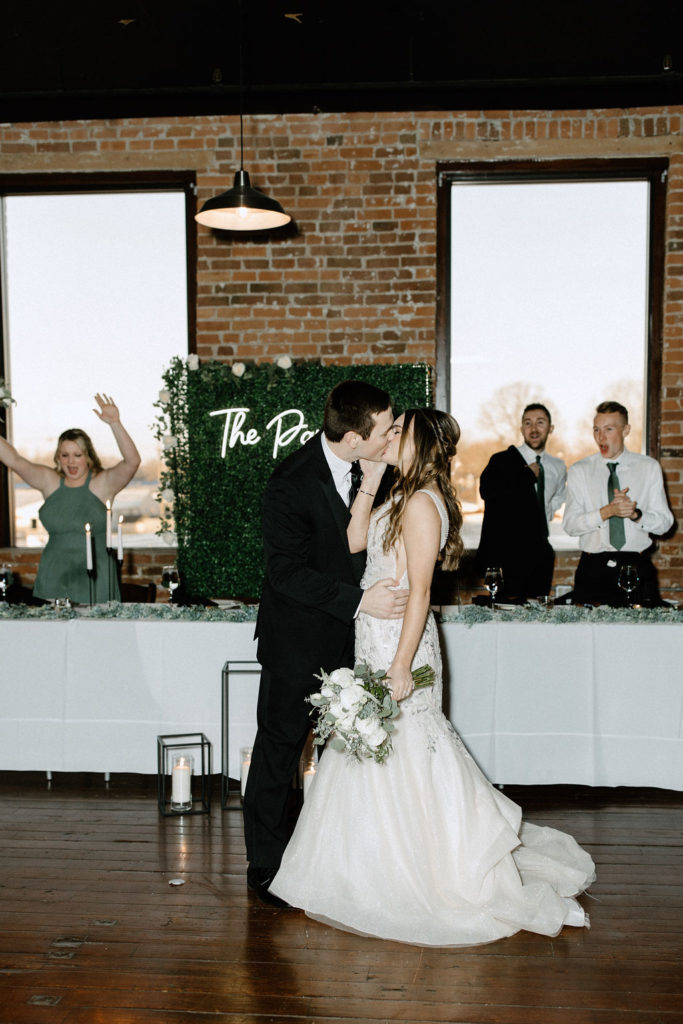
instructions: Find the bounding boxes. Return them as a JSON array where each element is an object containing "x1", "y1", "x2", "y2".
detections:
[{"x1": 562, "y1": 449, "x2": 674, "y2": 554}]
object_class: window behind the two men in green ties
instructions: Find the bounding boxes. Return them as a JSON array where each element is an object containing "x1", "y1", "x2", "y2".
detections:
[{"x1": 437, "y1": 161, "x2": 667, "y2": 548}]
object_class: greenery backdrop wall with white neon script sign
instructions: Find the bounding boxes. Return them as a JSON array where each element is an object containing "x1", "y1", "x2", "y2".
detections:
[{"x1": 155, "y1": 355, "x2": 432, "y2": 600}]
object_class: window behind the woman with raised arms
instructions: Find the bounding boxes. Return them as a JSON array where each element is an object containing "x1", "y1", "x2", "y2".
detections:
[{"x1": 0, "y1": 176, "x2": 194, "y2": 547}]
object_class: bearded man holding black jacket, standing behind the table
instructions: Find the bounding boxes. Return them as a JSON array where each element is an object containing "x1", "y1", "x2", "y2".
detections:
[{"x1": 477, "y1": 402, "x2": 566, "y2": 599}]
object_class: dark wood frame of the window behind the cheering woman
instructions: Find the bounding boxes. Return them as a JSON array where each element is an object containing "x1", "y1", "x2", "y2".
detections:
[{"x1": 0, "y1": 170, "x2": 197, "y2": 547}]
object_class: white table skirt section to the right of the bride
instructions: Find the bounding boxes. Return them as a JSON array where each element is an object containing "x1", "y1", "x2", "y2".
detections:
[{"x1": 442, "y1": 623, "x2": 683, "y2": 790}]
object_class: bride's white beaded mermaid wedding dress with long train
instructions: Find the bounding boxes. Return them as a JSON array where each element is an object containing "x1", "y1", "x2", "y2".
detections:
[{"x1": 270, "y1": 492, "x2": 595, "y2": 946}]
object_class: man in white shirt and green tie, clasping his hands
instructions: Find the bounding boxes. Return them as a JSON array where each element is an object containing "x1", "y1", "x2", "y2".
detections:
[{"x1": 562, "y1": 401, "x2": 674, "y2": 606}]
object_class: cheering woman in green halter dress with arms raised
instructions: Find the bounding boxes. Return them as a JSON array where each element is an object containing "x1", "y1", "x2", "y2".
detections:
[{"x1": 0, "y1": 394, "x2": 140, "y2": 604}]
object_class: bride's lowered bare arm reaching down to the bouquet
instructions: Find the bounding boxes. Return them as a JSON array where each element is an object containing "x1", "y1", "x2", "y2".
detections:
[{"x1": 387, "y1": 493, "x2": 441, "y2": 700}]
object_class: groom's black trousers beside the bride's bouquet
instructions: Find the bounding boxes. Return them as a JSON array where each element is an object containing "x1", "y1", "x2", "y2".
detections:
[{"x1": 244, "y1": 668, "x2": 315, "y2": 871}]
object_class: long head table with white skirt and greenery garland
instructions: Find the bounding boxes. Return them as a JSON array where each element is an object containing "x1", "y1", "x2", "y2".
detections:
[{"x1": 0, "y1": 604, "x2": 683, "y2": 790}]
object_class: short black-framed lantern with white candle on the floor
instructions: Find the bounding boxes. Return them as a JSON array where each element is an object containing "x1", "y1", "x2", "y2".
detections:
[{"x1": 157, "y1": 732, "x2": 211, "y2": 817}]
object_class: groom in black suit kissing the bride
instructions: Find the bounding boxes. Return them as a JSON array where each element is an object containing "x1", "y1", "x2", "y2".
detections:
[{"x1": 244, "y1": 380, "x2": 408, "y2": 906}]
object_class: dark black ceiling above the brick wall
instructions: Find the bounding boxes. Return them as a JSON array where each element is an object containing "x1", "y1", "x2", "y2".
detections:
[{"x1": 0, "y1": 0, "x2": 683, "y2": 123}]
